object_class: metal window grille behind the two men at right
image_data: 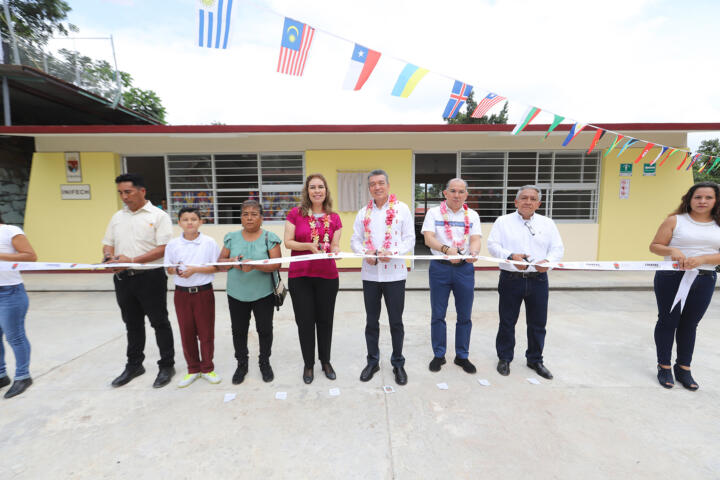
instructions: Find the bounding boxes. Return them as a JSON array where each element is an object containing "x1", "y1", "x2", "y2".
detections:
[{"x1": 460, "y1": 152, "x2": 600, "y2": 222}]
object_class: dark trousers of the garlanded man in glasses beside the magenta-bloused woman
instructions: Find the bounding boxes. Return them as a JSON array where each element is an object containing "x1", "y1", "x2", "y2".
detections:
[{"x1": 363, "y1": 280, "x2": 405, "y2": 367}]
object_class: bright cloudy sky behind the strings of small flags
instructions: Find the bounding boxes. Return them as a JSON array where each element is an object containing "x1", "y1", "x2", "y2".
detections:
[{"x1": 54, "y1": 0, "x2": 720, "y2": 147}]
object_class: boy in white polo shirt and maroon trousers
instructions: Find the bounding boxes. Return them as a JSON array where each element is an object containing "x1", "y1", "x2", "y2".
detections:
[{"x1": 165, "y1": 207, "x2": 221, "y2": 388}]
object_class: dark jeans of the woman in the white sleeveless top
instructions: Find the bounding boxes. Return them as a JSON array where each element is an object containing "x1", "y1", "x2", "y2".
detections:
[{"x1": 654, "y1": 270, "x2": 717, "y2": 367}]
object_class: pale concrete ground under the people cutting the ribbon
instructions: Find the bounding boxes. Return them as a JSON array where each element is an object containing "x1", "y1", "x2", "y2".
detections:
[{"x1": 0, "y1": 272, "x2": 720, "y2": 480}]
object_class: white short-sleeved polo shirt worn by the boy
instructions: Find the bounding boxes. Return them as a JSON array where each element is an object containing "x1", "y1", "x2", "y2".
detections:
[{"x1": 165, "y1": 233, "x2": 220, "y2": 287}]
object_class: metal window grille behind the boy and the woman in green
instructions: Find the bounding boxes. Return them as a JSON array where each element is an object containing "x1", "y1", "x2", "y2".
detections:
[{"x1": 146, "y1": 153, "x2": 305, "y2": 224}]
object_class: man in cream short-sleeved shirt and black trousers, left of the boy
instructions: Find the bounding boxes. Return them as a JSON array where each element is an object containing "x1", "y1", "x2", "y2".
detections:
[{"x1": 103, "y1": 173, "x2": 175, "y2": 388}]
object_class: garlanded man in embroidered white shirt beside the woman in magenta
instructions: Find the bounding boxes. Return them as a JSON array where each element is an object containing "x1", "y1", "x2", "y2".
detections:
[{"x1": 350, "y1": 170, "x2": 415, "y2": 385}]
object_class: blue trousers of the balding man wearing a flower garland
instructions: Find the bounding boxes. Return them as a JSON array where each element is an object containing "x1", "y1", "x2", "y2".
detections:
[{"x1": 429, "y1": 260, "x2": 475, "y2": 358}]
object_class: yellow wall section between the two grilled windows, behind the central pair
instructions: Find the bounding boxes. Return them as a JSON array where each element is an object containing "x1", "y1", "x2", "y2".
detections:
[{"x1": 305, "y1": 150, "x2": 413, "y2": 268}]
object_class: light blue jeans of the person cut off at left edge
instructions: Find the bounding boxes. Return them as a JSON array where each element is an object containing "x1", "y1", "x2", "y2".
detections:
[{"x1": 0, "y1": 283, "x2": 30, "y2": 380}]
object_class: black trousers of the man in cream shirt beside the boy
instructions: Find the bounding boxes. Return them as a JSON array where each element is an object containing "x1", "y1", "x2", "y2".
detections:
[{"x1": 113, "y1": 268, "x2": 175, "y2": 367}]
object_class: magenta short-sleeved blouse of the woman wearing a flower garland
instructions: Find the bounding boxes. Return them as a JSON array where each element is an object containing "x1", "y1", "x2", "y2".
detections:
[{"x1": 287, "y1": 207, "x2": 342, "y2": 279}]
